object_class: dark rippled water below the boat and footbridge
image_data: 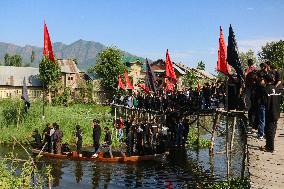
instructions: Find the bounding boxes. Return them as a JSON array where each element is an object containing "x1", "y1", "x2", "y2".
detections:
[{"x1": 0, "y1": 118, "x2": 247, "y2": 189}]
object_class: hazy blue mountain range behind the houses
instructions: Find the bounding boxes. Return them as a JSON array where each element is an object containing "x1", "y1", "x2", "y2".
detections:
[{"x1": 0, "y1": 39, "x2": 144, "y2": 71}]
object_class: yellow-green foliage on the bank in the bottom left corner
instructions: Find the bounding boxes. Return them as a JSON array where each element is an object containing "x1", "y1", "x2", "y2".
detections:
[{"x1": 0, "y1": 153, "x2": 52, "y2": 189}]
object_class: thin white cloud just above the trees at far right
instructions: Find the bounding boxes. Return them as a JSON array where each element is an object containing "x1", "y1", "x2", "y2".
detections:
[{"x1": 238, "y1": 37, "x2": 284, "y2": 52}]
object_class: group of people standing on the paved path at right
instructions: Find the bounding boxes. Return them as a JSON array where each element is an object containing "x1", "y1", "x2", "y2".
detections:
[{"x1": 245, "y1": 60, "x2": 283, "y2": 152}]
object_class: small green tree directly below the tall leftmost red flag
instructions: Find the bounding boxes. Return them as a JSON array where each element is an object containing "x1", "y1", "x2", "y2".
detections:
[{"x1": 39, "y1": 57, "x2": 61, "y2": 88}]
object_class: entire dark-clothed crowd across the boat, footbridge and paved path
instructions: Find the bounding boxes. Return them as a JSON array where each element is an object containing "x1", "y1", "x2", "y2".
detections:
[{"x1": 33, "y1": 59, "x2": 283, "y2": 157}]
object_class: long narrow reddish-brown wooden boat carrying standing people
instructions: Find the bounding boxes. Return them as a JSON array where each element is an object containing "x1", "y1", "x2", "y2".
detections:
[{"x1": 32, "y1": 149, "x2": 169, "y2": 163}]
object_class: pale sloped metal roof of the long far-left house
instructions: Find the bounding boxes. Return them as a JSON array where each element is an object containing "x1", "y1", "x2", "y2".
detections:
[{"x1": 0, "y1": 66, "x2": 42, "y2": 87}]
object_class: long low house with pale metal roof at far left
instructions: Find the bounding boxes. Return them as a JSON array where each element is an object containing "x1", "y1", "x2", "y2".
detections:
[{"x1": 0, "y1": 66, "x2": 42, "y2": 99}]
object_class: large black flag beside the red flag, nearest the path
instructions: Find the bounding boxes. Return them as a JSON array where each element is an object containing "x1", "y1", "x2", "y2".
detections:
[{"x1": 227, "y1": 25, "x2": 244, "y2": 81}]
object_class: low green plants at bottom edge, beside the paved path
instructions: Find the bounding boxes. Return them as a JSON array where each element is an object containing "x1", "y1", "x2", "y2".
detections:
[{"x1": 209, "y1": 178, "x2": 250, "y2": 189}]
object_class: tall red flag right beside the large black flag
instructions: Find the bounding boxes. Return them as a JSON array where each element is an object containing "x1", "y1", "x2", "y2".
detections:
[{"x1": 217, "y1": 26, "x2": 231, "y2": 74}]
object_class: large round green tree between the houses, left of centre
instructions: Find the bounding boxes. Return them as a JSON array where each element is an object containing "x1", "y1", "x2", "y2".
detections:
[{"x1": 94, "y1": 47, "x2": 124, "y2": 93}]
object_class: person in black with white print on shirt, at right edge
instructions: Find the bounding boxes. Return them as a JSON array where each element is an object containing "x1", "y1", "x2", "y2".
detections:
[{"x1": 262, "y1": 74, "x2": 281, "y2": 152}]
